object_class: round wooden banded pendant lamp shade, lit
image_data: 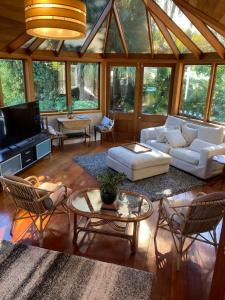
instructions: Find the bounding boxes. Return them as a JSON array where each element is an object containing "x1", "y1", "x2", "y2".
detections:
[{"x1": 25, "y1": 0, "x2": 86, "y2": 40}]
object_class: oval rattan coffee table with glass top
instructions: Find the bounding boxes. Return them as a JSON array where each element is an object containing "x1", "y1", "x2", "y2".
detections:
[{"x1": 67, "y1": 188, "x2": 153, "y2": 253}]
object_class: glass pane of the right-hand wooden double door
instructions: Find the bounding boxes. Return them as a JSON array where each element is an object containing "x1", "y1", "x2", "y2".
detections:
[{"x1": 142, "y1": 67, "x2": 172, "y2": 114}]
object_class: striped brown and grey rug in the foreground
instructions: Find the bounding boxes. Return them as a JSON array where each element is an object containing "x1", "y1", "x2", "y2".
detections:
[{"x1": 0, "y1": 241, "x2": 152, "y2": 300}]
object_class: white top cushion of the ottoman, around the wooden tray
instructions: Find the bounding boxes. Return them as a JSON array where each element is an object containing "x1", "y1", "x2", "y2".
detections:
[{"x1": 108, "y1": 147, "x2": 171, "y2": 170}]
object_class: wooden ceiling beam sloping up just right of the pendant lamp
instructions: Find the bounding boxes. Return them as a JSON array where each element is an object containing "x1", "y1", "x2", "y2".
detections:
[{"x1": 80, "y1": 0, "x2": 115, "y2": 56}]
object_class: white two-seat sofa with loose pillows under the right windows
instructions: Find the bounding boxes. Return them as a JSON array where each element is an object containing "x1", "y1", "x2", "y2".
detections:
[{"x1": 141, "y1": 116, "x2": 225, "y2": 179}]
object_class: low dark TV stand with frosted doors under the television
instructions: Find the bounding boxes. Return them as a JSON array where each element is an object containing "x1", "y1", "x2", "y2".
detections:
[{"x1": 0, "y1": 133, "x2": 51, "y2": 176}]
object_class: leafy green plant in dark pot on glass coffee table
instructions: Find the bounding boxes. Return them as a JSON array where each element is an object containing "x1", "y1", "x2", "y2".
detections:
[{"x1": 97, "y1": 170, "x2": 126, "y2": 204}]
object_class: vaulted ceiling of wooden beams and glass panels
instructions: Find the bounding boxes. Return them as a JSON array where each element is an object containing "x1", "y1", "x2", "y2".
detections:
[{"x1": 0, "y1": 0, "x2": 225, "y2": 59}]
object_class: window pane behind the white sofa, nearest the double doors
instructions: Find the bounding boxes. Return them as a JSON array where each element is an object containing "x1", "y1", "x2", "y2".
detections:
[{"x1": 180, "y1": 65, "x2": 211, "y2": 119}]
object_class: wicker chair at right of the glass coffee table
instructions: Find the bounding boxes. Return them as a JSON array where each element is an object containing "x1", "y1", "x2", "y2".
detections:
[{"x1": 154, "y1": 192, "x2": 225, "y2": 270}]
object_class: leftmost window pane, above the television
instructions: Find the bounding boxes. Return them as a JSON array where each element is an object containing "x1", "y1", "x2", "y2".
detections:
[{"x1": 0, "y1": 59, "x2": 26, "y2": 106}]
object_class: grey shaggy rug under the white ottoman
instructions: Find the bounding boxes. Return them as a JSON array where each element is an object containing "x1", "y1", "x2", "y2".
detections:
[{"x1": 74, "y1": 152, "x2": 205, "y2": 201}]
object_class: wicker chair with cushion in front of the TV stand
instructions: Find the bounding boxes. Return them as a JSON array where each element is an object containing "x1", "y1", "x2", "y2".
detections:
[{"x1": 0, "y1": 176, "x2": 72, "y2": 246}]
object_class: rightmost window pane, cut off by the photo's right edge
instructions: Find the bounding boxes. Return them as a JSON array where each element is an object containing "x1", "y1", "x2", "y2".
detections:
[{"x1": 210, "y1": 65, "x2": 225, "y2": 123}]
